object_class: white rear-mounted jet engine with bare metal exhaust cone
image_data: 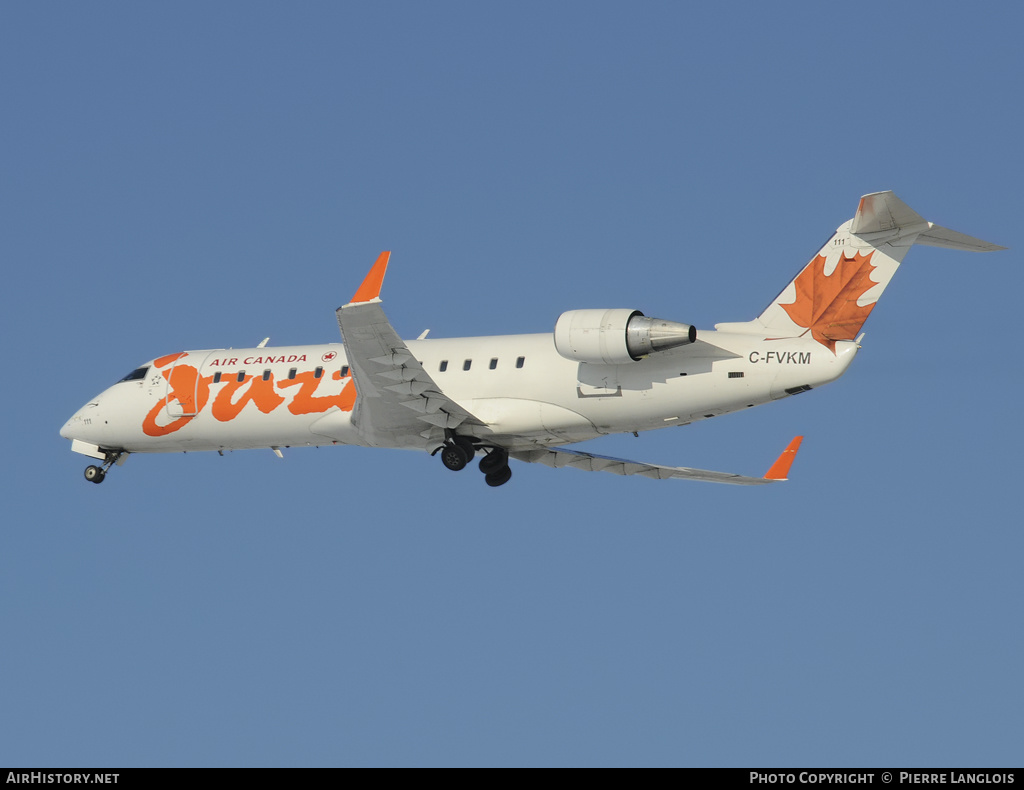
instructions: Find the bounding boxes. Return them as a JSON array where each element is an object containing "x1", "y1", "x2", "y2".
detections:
[{"x1": 555, "y1": 309, "x2": 697, "y2": 365}]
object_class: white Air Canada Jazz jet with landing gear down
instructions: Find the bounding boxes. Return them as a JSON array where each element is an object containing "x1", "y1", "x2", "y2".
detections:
[{"x1": 60, "y1": 192, "x2": 1006, "y2": 487}]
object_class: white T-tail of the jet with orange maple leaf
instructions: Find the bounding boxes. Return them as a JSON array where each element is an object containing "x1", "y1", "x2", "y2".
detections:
[{"x1": 716, "y1": 192, "x2": 1006, "y2": 352}]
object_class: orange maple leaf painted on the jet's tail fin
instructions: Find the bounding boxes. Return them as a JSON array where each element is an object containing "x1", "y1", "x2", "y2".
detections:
[{"x1": 779, "y1": 252, "x2": 876, "y2": 354}]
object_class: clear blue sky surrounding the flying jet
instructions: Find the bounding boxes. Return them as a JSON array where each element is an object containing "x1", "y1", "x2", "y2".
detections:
[{"x1": 0, "y1": 2, "x2": 1024, "y2": 766}]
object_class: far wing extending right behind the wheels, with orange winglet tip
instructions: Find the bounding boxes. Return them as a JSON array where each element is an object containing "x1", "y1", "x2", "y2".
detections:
[{"x1": 509, "y1": 436, "x2": 804, "y2": 486}]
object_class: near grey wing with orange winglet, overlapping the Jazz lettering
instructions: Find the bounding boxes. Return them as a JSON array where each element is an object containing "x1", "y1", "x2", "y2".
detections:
[{"x1": 337, "y1": 252, "x2": 483, "y2": 447}]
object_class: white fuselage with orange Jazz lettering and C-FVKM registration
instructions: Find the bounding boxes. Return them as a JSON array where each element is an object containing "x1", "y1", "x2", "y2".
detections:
[{"x1": 61, "y1": 331, "x2": 857, "y2": 453}]
